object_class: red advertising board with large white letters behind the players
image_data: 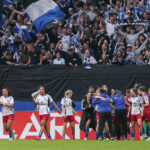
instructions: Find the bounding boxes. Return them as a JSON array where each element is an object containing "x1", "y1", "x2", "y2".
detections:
[{"x1": 0, "y1": 111, "x2": 139, "y2": 140}]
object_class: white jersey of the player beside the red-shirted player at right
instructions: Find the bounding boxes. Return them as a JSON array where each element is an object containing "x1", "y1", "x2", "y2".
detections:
[{"x1": 129, "y1": 96, "x2": 143, "y2": 115}]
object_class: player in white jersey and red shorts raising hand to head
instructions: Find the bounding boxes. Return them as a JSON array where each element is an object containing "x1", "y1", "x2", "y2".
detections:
[{"x1": 32, "y1": 86, "x2": 61, "y2": 140}]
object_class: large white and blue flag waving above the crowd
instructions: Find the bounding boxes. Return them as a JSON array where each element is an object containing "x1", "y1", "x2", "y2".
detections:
[{"x1": 22, "y1": 0, "x2": 65, "y2": 32}]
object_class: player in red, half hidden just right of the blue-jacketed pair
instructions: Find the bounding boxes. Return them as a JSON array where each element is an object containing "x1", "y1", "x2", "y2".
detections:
[{"x1": 125, "y1": 89, "x2": 131, "y2": 135}]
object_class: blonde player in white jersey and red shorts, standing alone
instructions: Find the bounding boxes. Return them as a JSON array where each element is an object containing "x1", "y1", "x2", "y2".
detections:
[{"x1": 61, "y1": 90, "x2": 77, "y2": 139}]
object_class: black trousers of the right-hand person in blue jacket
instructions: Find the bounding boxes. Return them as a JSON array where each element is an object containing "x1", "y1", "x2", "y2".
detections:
[{"x1": 114, "y1": 109, "x2": 127, "y2": 139}]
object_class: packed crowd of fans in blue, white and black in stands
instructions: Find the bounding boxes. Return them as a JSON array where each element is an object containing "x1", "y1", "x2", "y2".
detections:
[{"x1": 0, "y1": 0, "x2": 150, "y2": 68}]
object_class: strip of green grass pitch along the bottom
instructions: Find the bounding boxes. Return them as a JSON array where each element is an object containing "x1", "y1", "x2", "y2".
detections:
[{"x1": 0, "y1": 140, "x2": 150, "y2": 150}]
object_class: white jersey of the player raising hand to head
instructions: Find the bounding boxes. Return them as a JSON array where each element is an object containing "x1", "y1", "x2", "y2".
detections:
[{"x1": 35, "y1": 94, "x2": 53, "y2": 115}]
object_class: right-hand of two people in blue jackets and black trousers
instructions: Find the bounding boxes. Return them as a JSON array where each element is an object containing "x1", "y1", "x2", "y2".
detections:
[{"x1": 112, "y1": 91, "x2": 127, "y2": 140}]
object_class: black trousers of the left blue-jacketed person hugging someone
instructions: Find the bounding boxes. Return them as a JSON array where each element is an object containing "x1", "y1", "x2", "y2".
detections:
[{"x1": 99, "y1": 112, "x2": 114, "y2": 137}]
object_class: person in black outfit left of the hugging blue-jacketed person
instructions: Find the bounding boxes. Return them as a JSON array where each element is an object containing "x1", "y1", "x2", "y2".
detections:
[{"x1": 80, "y1": 93, "x2": 96, "y2": 140}]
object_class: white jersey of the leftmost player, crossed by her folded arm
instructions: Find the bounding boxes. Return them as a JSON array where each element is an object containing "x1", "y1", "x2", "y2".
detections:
[{"x1": 0, "y1": 96, "x2": 14, "y2": 116}]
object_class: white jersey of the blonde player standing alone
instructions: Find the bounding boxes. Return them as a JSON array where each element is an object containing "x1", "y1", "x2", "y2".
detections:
[{"x1": 61, "y1": 97, "x2": 73, "y2": 116}]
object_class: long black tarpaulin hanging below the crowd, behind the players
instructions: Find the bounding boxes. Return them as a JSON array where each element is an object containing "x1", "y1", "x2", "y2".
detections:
[{"x1": 0, "y1": 65, "x2": 150, "y2": 101}]
